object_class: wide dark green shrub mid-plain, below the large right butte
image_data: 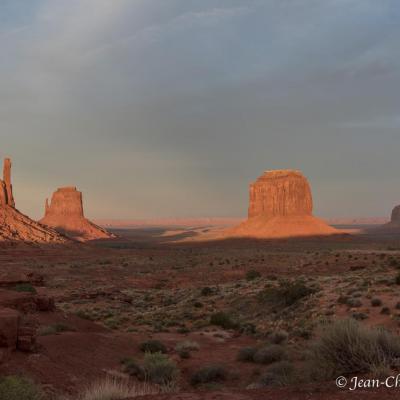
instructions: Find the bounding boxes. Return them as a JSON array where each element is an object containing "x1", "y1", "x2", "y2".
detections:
[{"x1": 259, "y1": 280, "x2": 316, "y2": 307}]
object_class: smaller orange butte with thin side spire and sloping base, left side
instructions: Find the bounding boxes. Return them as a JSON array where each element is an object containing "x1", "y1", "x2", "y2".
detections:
[{"x1": 39, "y1": 187, "x2": 114, "y2": 241}]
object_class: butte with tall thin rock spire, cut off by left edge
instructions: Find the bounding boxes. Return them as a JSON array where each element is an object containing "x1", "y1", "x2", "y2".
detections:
[{"x1": 0, "y1": 158, "x2": 67, "y2": 243}]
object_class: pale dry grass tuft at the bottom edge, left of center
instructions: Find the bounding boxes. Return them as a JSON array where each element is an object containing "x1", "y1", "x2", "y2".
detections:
[{"x1": 78, "y1": 378, "x2": 160, "y2": 400}]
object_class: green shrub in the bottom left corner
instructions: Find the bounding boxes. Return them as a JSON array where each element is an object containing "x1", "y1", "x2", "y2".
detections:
[{"x1": 0, "y1": 376, "x2": 43, "y2": 400}]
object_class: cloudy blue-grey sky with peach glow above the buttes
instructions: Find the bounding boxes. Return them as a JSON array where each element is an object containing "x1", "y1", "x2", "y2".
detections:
[{"x1": 0, "y1": 0, "x2": 400, "y2": 219}]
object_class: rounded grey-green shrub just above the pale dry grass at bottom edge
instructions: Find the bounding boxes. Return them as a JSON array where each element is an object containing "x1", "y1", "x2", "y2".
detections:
[{"x1": 143, "y1": 353, "x2": 179, "y2": 385}]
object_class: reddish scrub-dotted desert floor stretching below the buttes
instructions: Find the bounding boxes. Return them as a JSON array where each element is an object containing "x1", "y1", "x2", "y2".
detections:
[{"x1": 0, "y1": 230, "x2": 400, "y2": 399}]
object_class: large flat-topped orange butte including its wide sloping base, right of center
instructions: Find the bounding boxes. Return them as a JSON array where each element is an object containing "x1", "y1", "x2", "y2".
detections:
[{"x1": 226, "y1": 170, "x2": 339, "y2": 238}]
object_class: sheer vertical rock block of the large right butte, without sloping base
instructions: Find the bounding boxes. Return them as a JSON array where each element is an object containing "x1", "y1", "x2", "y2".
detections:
[{"x1": 249, "y1": 170, "x2": 313, "y2": 218}]
